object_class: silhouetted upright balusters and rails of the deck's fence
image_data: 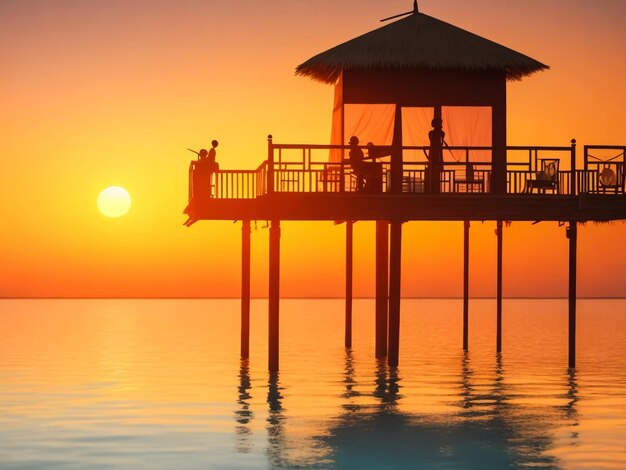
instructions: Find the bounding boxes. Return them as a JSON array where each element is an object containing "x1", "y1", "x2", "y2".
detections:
[{"x1": 189, "y1": 139, "x2": 625, "y2": 199}]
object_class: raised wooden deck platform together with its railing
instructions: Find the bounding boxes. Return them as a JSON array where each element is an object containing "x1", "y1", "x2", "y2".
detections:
[{"x1": 185, "y1": 140, "x2": 626, "y2": 222}]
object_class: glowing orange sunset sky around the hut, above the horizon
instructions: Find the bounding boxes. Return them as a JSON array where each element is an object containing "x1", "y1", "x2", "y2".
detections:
[{"x1": 0, "y1": 0, "x2": 626, "y2": 297}]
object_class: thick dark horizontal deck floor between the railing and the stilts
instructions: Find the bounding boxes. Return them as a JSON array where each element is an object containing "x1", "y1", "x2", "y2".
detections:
[{"x1": 188, "y1": 193, "x2": 626, "y2": 222}]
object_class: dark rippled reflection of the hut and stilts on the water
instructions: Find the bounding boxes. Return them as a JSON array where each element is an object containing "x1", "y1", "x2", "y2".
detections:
[{"x1": 247, "y1": 350, "x2": 578, "y2": 469}]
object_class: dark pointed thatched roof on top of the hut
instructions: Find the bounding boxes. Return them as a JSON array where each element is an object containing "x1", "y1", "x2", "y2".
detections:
[{"x1": 296, "y1": 12, "x2": 549, "y2": 83}]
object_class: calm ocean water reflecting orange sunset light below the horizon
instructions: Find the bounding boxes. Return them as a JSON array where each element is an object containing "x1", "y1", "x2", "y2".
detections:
[{"x1": 0, "y1": 300, "x2": 626, "y2": 469}]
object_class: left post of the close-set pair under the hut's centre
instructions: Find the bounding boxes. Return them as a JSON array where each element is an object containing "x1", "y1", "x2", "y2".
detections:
[{"x1": 376, "y1": 220, "x2": 389, "y2": 357}]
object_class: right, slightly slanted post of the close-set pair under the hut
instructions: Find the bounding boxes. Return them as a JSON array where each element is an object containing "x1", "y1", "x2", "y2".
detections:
[{"x1": 387, "y1": 221, "x2": 402, "y2": 367}]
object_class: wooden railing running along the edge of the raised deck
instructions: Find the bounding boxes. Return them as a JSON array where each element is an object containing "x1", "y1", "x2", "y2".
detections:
[{"x1": 189, "y1": 138, "x2": 626, "y2": 199}]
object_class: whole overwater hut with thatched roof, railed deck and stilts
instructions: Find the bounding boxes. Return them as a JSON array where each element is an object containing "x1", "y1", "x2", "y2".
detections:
[{"x1": 186, "y1": 2, "x2": 626, "y2": 371}]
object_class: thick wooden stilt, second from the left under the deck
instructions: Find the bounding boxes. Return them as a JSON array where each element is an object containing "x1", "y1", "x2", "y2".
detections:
[{"x1": 268, "y1": 220, "x2": 280, "y2": 372}]
